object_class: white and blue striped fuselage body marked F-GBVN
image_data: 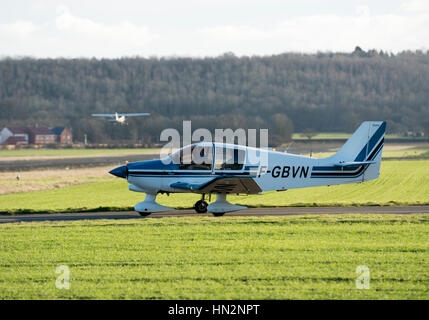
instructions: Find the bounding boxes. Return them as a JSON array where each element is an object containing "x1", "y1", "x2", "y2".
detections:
[{"x1": 123, "y1": 144, "x2": 382, "y2": 193}]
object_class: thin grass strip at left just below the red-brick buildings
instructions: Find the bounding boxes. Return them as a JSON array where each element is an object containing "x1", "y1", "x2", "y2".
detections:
[{"x1": 0, "y1": 148, "x2": 160, "y2": 157}]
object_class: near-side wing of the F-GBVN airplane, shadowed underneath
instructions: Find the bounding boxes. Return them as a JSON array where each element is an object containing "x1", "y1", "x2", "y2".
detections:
[{"x1": 170, "y1": 176, "x2": 262, "y2": 194}]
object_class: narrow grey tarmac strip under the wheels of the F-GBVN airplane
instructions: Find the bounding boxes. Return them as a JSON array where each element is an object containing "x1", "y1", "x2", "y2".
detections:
[{"x1": 0, "y1": 206, "x2": 429, "y2": 223}]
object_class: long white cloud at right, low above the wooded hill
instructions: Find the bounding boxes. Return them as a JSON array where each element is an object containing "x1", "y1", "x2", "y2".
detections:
[{"x1": 198, "y1": 5, "x2": 429, "y2": 55}]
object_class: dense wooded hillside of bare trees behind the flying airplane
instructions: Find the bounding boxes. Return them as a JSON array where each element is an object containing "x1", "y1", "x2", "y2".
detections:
[{"x1": 0, "y1": 48, "x2": 429, "y2": 145}]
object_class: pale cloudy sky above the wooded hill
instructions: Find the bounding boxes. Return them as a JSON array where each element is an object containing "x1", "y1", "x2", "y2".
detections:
[{"x1": 0, "y1": 0, "x2": 429, "y2": 58}]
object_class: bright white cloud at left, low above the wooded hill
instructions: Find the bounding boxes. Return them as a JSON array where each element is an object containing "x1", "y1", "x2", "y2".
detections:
[{"x1": 0, "y1": 7, "x2": 158, "y2": 57}]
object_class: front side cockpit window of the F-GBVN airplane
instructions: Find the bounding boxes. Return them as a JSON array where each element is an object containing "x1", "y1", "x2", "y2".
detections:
[{"x1": 171, "y1": 145, "x2": 213, "y2": 170}]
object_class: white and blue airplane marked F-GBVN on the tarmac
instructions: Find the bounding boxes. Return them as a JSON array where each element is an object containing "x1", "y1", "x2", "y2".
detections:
[{"x1": 110, "y1": 121, "x2": 386, "y2": 216}]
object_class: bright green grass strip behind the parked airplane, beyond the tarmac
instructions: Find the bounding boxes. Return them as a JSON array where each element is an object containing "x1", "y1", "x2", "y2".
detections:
[{"x1": 0, "y1": 160, "x2": 429, "y2": 213}]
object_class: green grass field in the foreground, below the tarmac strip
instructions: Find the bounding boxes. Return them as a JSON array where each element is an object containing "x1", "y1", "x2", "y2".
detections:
[{"x1": 0, "y1": 215, "x2": 429, "y2": 299}]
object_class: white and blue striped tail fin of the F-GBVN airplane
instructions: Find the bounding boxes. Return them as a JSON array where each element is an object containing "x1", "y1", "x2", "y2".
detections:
[{"x1": 329, "y1": 121, "x2": 386, "y2": 181}]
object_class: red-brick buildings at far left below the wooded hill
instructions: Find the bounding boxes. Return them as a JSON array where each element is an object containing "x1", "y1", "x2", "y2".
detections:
[{"x1": 0, "y1": 127, "x2": 73, "y2": 145}]
